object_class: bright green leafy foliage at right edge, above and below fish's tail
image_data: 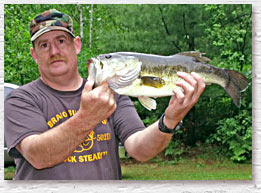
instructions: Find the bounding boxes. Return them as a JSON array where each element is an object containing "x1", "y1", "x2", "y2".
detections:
[{"x1": 202, "y1": 5, "x2": 252, "y2": 161}]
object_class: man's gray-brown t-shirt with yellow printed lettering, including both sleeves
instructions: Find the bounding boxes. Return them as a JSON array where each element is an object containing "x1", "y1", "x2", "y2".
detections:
[{"x1": 4, "y1": 78, "x2": 144, "y2": 180}]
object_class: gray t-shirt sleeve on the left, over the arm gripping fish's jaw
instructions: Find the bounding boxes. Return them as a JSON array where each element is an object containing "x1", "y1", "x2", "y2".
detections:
[{"x1": 4, "y1": 89, "x2": 48, "y2": 157}]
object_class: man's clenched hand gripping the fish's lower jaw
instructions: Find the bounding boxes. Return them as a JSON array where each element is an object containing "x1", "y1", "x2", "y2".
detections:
[{"x1": 79, "y1": 80, "x2": 117, "y2": 128}]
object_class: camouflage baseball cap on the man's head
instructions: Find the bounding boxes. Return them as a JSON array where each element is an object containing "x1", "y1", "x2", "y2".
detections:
[{"x1": 30, "y1": 9, "x2": 75, "y2": 42}]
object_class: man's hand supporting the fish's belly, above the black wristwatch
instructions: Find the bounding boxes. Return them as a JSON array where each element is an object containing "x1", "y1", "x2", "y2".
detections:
[{"x1": 164, "y1": 72, "x2": 206, "y2": 128}]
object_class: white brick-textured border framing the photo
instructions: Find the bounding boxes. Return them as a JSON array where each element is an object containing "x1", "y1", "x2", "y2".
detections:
[{"x1": 0, "y1": 0, "x2": 261, "y2": 193}]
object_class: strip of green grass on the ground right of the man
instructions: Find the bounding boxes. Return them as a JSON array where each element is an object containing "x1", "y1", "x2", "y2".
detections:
[{"x1": 122, "y1": 158, "x2": 252, "y2": 180}]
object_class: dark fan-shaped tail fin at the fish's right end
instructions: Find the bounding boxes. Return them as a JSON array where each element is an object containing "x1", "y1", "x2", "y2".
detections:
[{"x1": 222, "y1": 70, "x2": 249, "y2": 108}]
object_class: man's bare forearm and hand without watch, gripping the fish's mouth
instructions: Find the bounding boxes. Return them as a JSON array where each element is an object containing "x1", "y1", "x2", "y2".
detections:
[{"x1": 16, "y1": 81, "x2": 116, "y2": 169}]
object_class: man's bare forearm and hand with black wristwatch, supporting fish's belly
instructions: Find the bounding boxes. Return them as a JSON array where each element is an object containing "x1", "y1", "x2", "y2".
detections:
[{"x1": 124, "y1": 72, "x2": 205, "y2": 161}]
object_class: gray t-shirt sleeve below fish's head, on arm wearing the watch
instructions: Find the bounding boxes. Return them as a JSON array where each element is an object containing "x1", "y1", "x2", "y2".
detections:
[{"x1": 113, "y1": 95, "x2": 145, "y2": 144}]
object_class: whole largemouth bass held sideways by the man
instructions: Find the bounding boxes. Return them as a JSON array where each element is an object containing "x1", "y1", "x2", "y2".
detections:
[{"x1": 88, "y1": 51, "x2": 249, "y2": 110}]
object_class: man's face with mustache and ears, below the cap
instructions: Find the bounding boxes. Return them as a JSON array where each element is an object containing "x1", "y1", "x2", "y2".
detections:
[{"x1": 31, "y1": 31, "x2": 81, "y2": 79}]
